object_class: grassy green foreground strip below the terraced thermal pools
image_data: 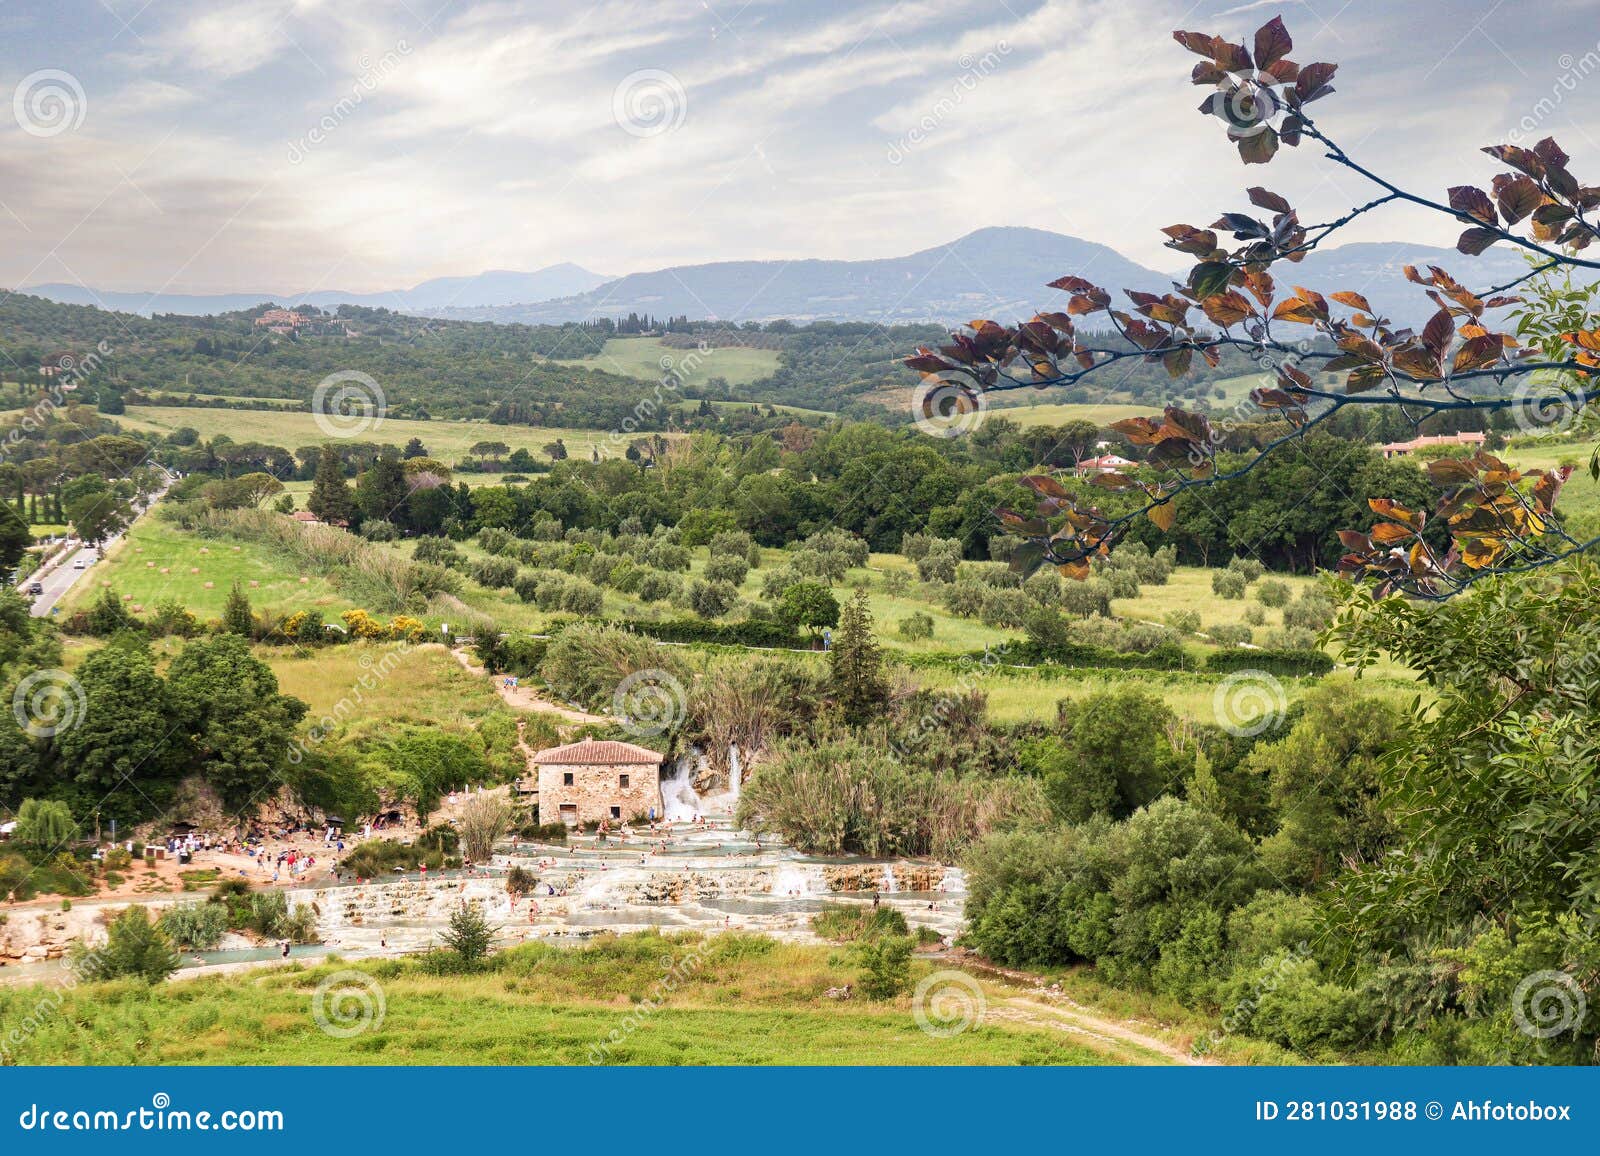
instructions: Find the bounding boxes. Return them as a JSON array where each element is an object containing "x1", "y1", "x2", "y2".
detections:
[{"x1": 0, "y1": 933, "x2": 1132, "y2": 1065}]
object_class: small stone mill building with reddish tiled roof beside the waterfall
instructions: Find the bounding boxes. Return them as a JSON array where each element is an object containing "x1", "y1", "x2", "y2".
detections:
[{"x1": 533, "y1": 738, "x2": 664, "y2": 826}]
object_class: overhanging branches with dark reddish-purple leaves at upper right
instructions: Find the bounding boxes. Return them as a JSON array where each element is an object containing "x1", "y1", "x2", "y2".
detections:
[{"x1": 907, "y1": 18, "x2": 1600, "y2": 599}]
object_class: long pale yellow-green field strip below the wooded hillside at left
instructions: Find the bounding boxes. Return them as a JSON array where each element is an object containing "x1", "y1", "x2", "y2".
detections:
[{"x1": 117, "y1": 405, "x2": 643, "y2": 464}]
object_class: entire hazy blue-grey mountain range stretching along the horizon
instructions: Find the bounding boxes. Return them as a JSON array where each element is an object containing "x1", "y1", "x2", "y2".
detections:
[{"x1": 27, "y1": 227, "x2": 1574, "y2": 325}]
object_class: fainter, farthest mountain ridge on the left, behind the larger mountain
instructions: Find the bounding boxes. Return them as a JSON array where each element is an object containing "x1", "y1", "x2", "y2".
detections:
[{"x1": 26, "y1": 264, "x2": 610, "y2": 315}]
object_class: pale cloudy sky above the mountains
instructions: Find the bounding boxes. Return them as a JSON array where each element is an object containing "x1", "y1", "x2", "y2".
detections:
[{"x1": 0, "y1": 0, "x2": 1600, "y2": 293}]
